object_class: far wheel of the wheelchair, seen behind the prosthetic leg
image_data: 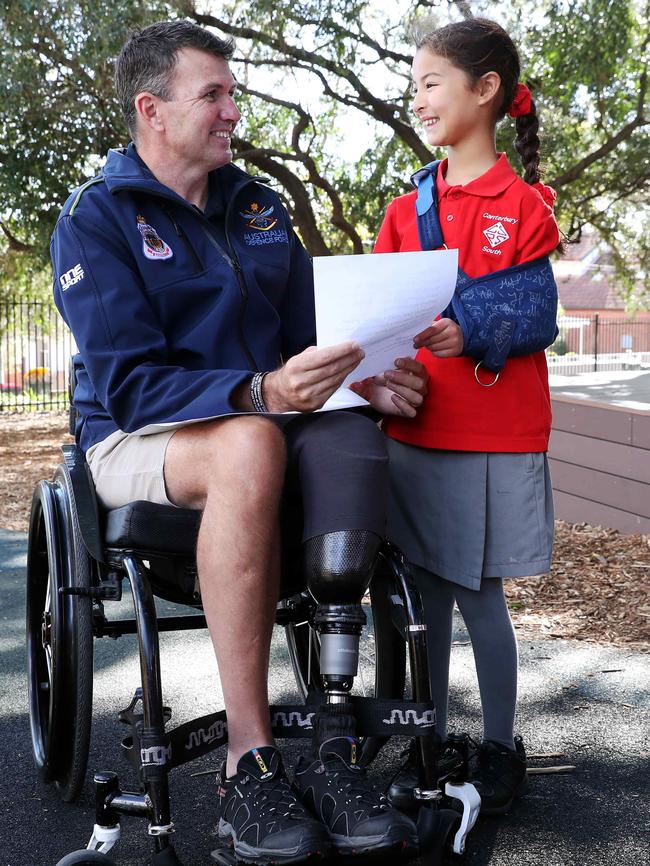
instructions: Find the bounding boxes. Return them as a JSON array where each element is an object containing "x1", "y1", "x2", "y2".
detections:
[{"x1": 285, "y1": 557, "x2": 406, "y2": 764}]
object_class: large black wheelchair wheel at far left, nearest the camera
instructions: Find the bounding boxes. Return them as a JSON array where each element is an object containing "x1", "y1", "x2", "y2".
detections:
[{"x1": 27, "y1": 466, "x2": 93, "y2": 802}]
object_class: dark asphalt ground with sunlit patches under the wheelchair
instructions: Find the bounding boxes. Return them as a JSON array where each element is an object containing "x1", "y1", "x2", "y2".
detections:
[{"x1": 0, "y1": 530, "x2": 650, "y2": 866}]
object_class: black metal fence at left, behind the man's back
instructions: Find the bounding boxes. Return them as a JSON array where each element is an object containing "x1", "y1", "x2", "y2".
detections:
[{"x1": 0, "y1": 301, "x2": 76, "y2": 412}]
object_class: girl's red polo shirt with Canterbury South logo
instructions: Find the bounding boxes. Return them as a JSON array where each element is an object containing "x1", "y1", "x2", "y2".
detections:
[{"x1": 375, "y1": 154, "x2": 559, "y2": 452}]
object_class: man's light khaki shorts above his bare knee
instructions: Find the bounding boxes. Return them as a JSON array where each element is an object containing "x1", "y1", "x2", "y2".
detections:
[{"x1": 86, "y1": 429, "x2": 176, "y2": 509}]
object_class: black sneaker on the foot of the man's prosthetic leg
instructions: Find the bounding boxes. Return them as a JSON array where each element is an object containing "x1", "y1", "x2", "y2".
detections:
[{"x1": 293, "y1": 737, "x2": 418, "y2": 854}]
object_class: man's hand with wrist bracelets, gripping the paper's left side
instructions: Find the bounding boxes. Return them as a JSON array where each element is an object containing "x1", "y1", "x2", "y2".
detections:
[{"x1": 263, "y1": 343, "x2": 364, "y2": 412}]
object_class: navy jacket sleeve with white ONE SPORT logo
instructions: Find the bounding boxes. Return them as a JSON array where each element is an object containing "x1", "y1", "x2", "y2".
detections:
[{"x1": 51, "y1": 207, "x2": 251, "y2": 433}]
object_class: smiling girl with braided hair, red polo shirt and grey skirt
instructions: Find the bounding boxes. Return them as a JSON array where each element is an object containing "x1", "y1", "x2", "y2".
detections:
[{"x1": 375, "y1": 18, "x2": 559, "y2": 814}]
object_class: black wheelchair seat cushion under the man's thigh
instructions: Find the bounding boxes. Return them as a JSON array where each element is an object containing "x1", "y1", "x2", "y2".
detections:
[{"x1": 104, "y1": 501, "x2": 202, "y2": 556}]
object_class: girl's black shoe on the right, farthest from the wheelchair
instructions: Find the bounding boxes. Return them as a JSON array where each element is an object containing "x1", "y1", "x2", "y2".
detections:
[{"x1": 470, "y1": 737, "x2": 527, "y2": 815}]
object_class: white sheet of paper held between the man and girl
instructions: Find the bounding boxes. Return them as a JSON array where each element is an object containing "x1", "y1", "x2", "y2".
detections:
[{"x1": 314, "y1": 250, "x2": 458, "y2": 410}]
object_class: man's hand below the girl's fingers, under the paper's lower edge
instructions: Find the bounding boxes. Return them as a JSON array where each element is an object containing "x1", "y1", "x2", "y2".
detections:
[{"x1": 350, "y1": 358, "x2": 429, "y2": 418}]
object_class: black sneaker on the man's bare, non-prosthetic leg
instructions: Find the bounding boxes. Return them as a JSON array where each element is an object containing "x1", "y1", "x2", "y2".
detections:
[{"x1": 217, "y1": 746, "x2": 332, "y2": 863}]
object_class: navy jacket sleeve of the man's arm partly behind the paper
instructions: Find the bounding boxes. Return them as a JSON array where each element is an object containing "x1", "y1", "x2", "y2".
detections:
[{"x1": 282, "y1": 226, "x2": 316, "y2": 361}]
